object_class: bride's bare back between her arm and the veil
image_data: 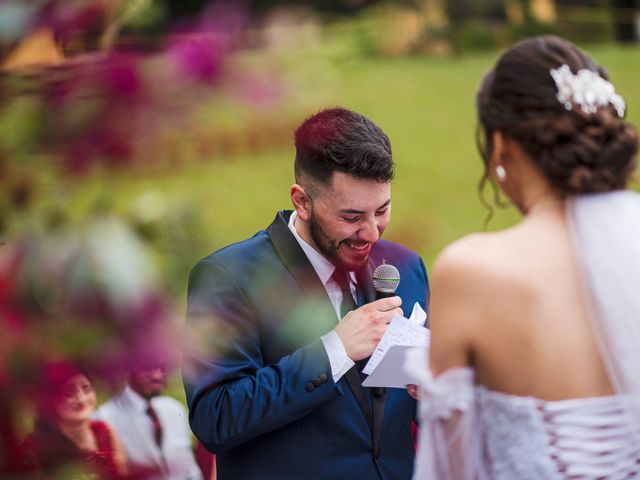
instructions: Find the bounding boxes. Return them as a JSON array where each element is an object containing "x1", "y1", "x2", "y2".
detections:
[{"x1": 459, "y1": 212, "x2": 612, "y2": 400}]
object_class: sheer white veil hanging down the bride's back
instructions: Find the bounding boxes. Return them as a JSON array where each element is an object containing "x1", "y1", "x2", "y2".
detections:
[{"x1": 566, "y1": 191, "x2": 640, "y2": 444}]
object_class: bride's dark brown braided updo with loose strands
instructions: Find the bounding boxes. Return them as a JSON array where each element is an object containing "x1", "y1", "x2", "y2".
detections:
[{"x1": 477, "y1": 36, "x2": 638, "y2": 195}]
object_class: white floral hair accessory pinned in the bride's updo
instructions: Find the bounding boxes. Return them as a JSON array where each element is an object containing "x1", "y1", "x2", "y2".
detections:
[{"x1": 550, "y1": 65, "x2": 625, "y2": 117}]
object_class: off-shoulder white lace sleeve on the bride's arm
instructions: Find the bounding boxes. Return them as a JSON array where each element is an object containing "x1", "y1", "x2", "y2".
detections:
[{"x1": 405, "y1": 350, "x2": 487, "y2": 480}]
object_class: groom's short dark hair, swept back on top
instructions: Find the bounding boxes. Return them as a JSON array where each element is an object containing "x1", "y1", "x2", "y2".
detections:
[{"x1": 294, "y1": 108, "x2": 394, "y2": 193}]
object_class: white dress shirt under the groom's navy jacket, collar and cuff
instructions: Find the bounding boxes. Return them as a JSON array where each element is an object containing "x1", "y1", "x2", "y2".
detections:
[{"x1": 289, "y1": 211, "x2": 357, "y2": 383}]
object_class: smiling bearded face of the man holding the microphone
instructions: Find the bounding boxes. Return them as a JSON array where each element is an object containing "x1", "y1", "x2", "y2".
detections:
[{"x1": 307, "y1": 172, "x2": 391, "y2": 271}]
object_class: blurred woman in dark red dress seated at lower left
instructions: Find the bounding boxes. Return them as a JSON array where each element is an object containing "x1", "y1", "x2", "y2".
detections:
[{"x1": 25, "y1": 362, "x2": 127, "y2": 479}]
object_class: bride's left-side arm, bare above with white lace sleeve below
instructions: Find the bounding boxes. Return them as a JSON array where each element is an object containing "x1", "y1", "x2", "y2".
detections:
[{"x1": 414, "y1": 242, "x2": 483, "y2": 480}]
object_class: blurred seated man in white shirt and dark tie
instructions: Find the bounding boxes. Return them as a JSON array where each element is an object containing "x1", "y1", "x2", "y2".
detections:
[{"x1": 96, "y1": 362, "x2": 202, "y2": 480}]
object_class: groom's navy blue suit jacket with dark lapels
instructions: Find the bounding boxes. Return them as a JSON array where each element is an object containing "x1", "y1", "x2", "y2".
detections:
[{"x1": 183, "y1": 212, "x2": 428, "y2": 480}]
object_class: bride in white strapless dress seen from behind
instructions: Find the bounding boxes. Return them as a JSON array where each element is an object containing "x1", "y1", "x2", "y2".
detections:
[{"x1": 407, "y1": 36, "x2": 640, "y2": 480}]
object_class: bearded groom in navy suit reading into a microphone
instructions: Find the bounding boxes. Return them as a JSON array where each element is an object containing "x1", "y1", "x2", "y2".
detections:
[{"x1": 183, "y1": 108, "x2": 428, "y2": 480}]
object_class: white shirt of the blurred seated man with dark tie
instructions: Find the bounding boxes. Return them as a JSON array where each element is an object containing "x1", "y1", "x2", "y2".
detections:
[{"x1": 95, "y1": 385, "x2": 202, "y2": 480}]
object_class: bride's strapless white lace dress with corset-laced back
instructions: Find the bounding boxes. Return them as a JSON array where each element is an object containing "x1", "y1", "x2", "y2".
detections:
[{"x1": 409, "y1": 356, "x2": 640, "y2": 480}]
